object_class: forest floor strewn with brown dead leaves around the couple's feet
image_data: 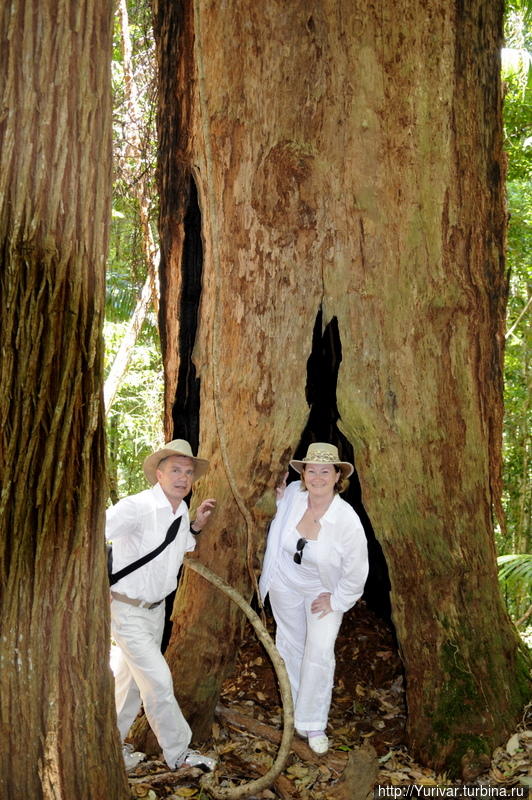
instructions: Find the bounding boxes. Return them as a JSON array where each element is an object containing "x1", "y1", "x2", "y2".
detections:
[{"x1": 125, "y1": 603, "x2": 532, "y2": 800}]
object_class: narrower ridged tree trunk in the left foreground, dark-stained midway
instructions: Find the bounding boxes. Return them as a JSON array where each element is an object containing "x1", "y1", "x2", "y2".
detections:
[{"x1": 0, "y1": 0, "x2": 129, "y2": 800}]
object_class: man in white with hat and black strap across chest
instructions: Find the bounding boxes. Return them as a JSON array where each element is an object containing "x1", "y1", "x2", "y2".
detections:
[{"x1": 105, "y1": 439, "x2": 216, "y2": 771}]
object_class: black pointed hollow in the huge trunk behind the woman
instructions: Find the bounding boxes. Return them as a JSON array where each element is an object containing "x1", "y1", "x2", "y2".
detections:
[{"x1": 289, "y1": 308, "x2": 391, "y2": 621}]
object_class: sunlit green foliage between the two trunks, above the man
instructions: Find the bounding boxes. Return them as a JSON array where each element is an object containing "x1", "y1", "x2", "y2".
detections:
[{"x1": 104, "y1": 0, "x2": 163, "y2": 500}]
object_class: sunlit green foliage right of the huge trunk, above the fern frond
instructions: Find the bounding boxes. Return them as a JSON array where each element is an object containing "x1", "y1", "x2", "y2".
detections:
[{"x1": 497, "y1": 7, "x2": 532, "y2": 568}]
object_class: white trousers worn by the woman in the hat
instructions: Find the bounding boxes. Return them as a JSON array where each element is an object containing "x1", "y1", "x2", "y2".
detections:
[{"x1": 269, "y1": 583, "x2": 343, "y2": 732}]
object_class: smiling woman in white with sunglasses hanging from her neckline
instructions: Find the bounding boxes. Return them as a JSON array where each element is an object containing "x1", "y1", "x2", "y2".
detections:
[{"x1": 259, "y1": 442, "x2": 368, "y2": 754}]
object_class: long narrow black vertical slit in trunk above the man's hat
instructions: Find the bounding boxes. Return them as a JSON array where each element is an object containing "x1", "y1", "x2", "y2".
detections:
[{"x1": 172, "y1": 175, "x2": 203, "y2": 453}]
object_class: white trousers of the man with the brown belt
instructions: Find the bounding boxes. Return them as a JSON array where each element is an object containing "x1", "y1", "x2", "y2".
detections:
[{"x1": 111, "y1": 600, "x2": 192, "y2": 768}]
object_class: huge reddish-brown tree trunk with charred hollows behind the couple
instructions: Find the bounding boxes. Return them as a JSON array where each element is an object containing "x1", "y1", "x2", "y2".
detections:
[{"x1": 149, "y1": 0, "x2": 525, "y2": 768}]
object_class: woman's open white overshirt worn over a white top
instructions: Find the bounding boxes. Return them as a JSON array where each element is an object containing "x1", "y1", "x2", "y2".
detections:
[{"x1": 259, "y1": 481, "x2": 368, "y2": 611}]
